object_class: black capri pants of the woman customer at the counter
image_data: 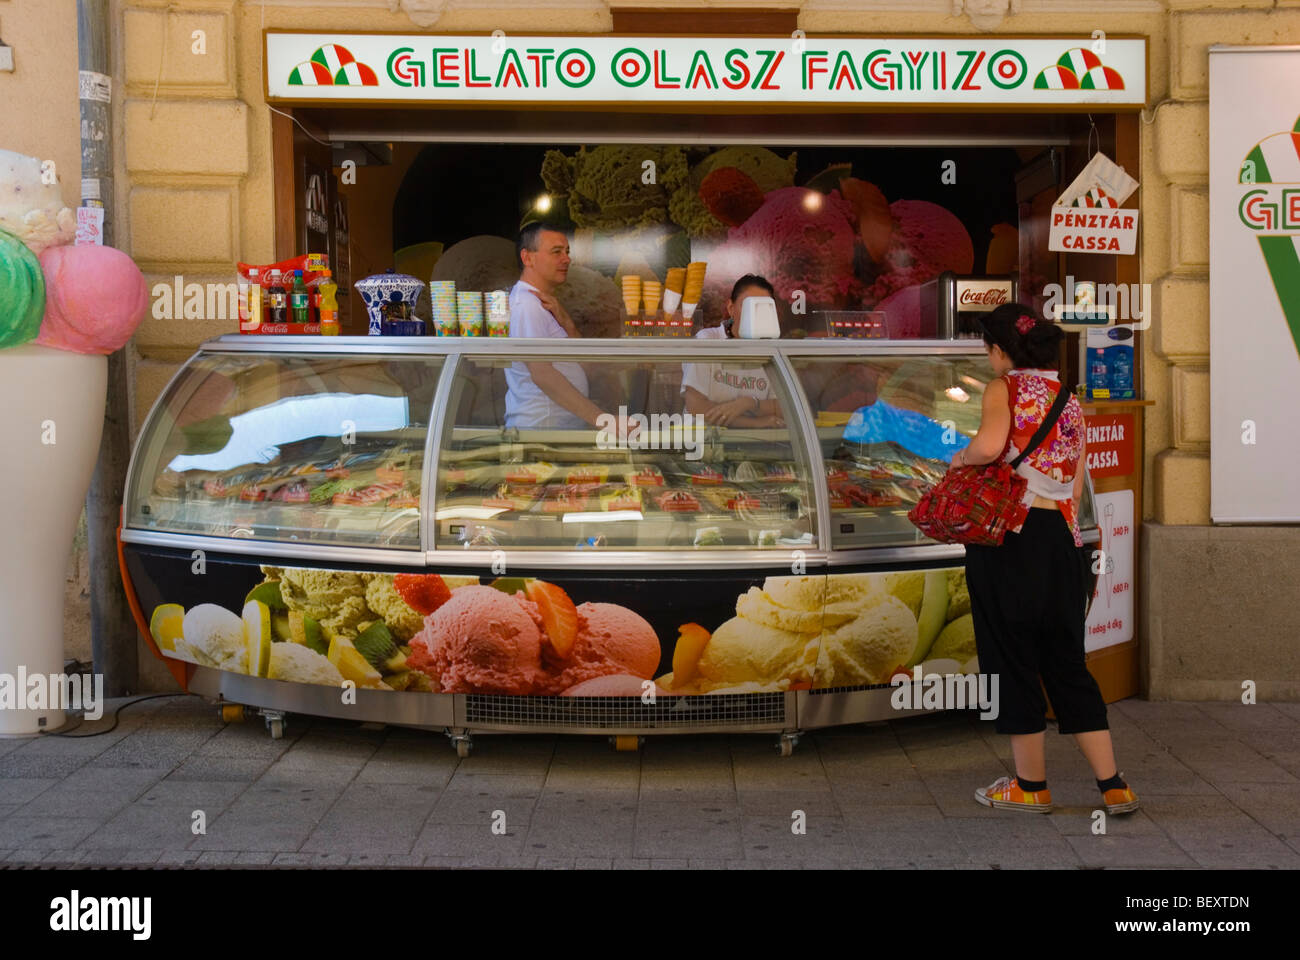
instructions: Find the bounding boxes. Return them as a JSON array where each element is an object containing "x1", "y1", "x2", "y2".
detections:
[{"x1": 966, "y1": 507, "x2": 1108, "y2": 734}]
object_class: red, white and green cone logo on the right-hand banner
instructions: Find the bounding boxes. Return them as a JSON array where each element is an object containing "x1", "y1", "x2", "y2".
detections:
[{"x1": 1236, "y1": 117, "x2": 1300, "y2": 351}]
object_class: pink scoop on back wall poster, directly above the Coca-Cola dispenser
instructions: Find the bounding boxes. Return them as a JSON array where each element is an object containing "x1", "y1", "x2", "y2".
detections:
[{"x1": 870, "y1": 200, "x2": 975, "y2": 302}]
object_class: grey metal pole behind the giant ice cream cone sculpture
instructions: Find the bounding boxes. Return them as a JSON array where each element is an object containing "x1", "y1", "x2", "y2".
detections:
[{"x1": 77, "y1": 0, "x2": 139, "y2": 697}]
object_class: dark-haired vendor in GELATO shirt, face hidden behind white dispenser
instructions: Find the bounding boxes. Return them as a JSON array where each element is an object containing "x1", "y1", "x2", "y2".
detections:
[{"x1": 681, "y1": 273, "x2": 785, "y2": 427}]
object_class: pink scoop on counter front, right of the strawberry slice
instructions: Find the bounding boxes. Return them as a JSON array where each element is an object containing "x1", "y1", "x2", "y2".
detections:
[{"x1": 540, "y1": 604, "x2": 660, "y2": 696}]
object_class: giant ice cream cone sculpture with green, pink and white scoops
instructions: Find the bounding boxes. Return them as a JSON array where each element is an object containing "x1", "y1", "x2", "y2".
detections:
[{"x1": 0, "y1": 150, "x2": 148, "y2": 738}]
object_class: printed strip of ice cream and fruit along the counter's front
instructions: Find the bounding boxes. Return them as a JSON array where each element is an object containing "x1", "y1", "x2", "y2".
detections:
[{"x1": 150, "y1": 566, "x2": 978, "y2": 697}]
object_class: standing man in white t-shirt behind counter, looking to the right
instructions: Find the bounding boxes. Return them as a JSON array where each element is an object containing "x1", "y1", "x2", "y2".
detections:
[{"x1": 506, "y1": 222, "x2": 616, "y2": 429}]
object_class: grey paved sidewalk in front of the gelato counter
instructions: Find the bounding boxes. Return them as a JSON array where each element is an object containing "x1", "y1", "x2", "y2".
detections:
[{"x1": 0, "y1": 697, "x2": 1300, "y2": 869}]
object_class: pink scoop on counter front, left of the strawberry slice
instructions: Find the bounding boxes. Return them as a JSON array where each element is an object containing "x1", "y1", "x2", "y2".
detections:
[{"x1": 408, "y1": 585, "x2": 541, "y2": 693}]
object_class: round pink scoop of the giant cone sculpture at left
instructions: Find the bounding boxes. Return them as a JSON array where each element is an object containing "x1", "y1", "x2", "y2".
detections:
[{"x1": 36, "y1": 246, "x2": 150, "y2": 354}]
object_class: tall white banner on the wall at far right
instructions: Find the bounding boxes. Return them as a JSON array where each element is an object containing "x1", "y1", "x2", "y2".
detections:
[{"x1": 1206, "y1": 47, "x2": 1300, "y2": 523}]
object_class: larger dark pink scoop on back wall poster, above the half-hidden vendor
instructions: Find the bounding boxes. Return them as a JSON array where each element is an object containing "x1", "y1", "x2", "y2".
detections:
[{"x1": 707, "y1": 187, "x2": 859, "y2": 316}]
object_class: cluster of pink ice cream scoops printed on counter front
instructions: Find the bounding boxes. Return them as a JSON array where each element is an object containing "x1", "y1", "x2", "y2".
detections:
[{"x1": 407, "y1": 585, "x2": 668, "y2": 696}]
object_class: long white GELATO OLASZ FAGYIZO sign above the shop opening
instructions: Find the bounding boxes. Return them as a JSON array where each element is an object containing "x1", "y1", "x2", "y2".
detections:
[{"x1": 265, "y1": 31, "x2": 1147, "y2": 108}]
